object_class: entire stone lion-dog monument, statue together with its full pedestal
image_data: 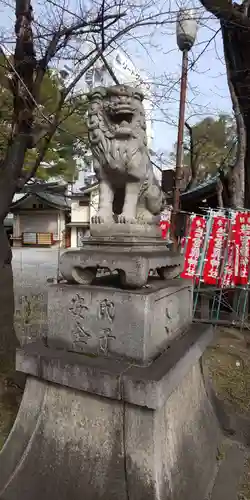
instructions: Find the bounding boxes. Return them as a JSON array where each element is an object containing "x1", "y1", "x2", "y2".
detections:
[{"x1": 0, "y1": 85, "x2": 219, "y2": 500}]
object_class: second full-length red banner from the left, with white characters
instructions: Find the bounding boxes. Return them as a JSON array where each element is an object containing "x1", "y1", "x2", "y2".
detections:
[{"x1": 203, "y1": 216, "x2": 228, "y2": 285}]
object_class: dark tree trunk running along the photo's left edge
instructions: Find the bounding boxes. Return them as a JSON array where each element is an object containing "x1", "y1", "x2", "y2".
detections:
[{"x1": 0, "y1": 0, "x2": 36, "y2": 382}]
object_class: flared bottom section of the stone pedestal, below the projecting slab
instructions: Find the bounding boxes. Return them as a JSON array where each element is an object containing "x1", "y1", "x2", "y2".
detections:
[{"x1": 0, "y1": 324, "x2": 219, "y2": 500}]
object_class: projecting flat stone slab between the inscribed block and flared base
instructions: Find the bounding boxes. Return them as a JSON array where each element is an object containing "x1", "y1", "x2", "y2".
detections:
[{"x1": 16, "y1": 324, "x2": 213, "y2": 410}]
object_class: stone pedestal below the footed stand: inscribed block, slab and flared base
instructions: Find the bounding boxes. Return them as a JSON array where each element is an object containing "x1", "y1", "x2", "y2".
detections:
[{"x1": 0, "y1": 280, "x2": 219, "y2": 500}]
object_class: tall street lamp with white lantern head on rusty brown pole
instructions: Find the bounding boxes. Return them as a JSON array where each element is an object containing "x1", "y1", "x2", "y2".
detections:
[{"x1": 173, "y1": 9, "x2": 197, "y2": 218}]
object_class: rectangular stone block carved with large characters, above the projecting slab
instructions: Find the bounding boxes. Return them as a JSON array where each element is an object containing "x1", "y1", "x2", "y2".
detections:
[{"x1": 47, "y1": 280, "x2": 192, "y2": 364}]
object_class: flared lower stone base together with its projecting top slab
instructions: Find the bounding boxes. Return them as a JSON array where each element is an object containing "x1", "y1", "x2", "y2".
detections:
[{"x1": 0, "y1": 325, "x2": 220, "y2": 500}]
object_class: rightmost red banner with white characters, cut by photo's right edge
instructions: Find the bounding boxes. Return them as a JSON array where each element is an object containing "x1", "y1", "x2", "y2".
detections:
[{"x1": 235, "y1": 212, "x2": 250, "y2": 285}]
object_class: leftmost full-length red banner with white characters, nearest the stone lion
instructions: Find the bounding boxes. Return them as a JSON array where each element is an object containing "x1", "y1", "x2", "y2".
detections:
[{"x1": 180, "y1": 215, "x2": 206, "y2": 279}]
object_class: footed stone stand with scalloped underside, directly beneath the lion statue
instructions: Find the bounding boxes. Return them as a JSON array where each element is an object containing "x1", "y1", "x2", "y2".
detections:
[{"x1": 60, "y1": 237, "x2": 183, "y2": 288}]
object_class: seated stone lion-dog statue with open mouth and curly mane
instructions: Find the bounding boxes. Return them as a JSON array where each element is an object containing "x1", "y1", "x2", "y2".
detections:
[{"x1": 88, "y1": 85, "x2": 164, "y2": 223}]
